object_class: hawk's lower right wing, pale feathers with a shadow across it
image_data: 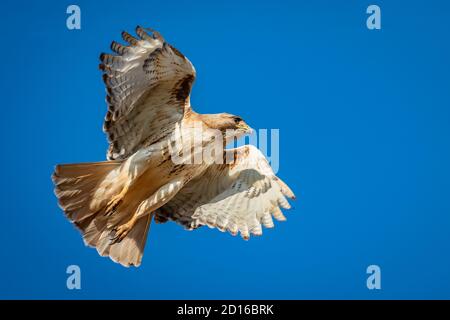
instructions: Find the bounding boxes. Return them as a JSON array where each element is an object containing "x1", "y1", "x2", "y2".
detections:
[{"x1": 155, "y1": 146, "x2": 295, "y2": 239}]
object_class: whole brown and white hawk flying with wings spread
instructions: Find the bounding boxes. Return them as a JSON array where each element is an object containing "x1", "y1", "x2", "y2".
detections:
[{"x1": 52, "y1": 26, "x2": 295, "y2": 266}]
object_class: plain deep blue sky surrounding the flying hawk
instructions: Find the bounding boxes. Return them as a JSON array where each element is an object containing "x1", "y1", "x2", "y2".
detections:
[{"x1": 0, "y1": 0, "x2": 450, "y2": 299}]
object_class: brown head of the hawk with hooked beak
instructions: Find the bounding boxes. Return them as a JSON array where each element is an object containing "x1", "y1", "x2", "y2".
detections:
[{"x1": 202, "y1": 113, "x2": 253, "y2": 138}]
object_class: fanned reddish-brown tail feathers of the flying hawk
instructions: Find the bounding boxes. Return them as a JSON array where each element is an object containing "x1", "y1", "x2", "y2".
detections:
[{"x1": 52, "y1": 161, "x2": 152, "y2": 267}]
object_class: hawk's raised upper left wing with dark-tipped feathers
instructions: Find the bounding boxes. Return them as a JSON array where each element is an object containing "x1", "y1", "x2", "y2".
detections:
[{"x1": 100, "y1": 26, "x2": 195, "y2": 160}]
